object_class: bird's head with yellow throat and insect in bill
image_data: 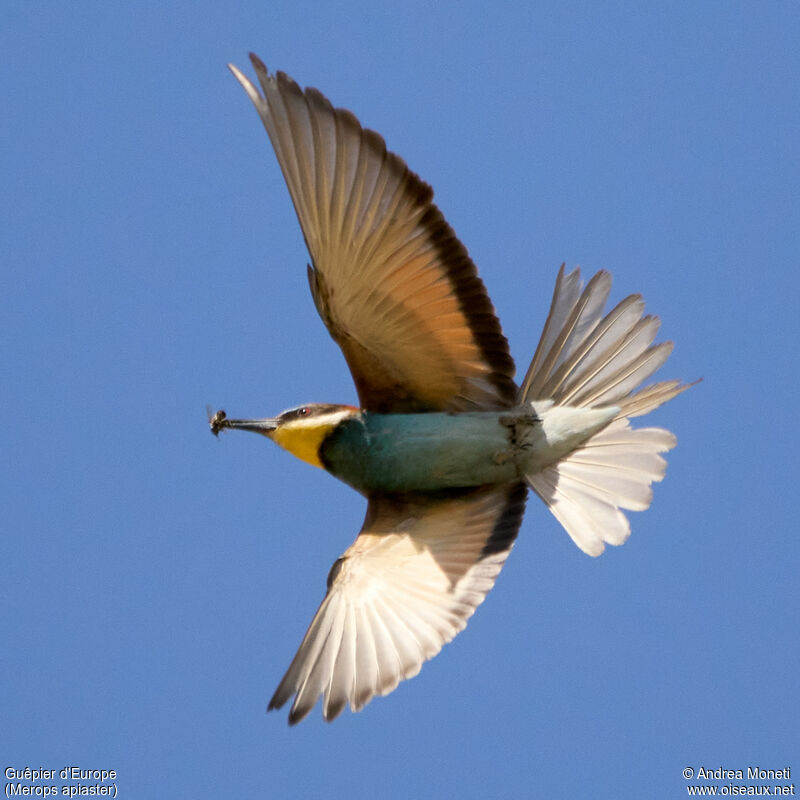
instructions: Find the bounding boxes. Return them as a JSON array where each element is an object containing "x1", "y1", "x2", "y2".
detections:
[{"x1": 209, "y1": 403, "x2": 359, "y2": 469}]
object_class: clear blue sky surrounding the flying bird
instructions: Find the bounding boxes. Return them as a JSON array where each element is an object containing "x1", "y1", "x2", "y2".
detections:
[{"x1": 0, "y1": 0, "x2": 800, "y2": 798}]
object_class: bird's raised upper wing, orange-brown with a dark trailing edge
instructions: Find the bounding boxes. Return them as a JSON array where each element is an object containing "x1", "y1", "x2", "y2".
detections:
[{"x1": 230, "y1": 55, "x2": 516, "y2": 413}]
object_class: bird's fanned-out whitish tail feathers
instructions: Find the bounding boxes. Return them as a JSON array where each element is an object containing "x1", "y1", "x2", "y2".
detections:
[{"x1": 518, "y1": 266, "x2": 690, "y2": 556}]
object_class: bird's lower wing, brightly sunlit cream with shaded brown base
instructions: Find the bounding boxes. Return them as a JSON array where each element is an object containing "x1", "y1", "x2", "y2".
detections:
[{"x1": 269, "y1": 484, "x2": 526, "y2": 724}]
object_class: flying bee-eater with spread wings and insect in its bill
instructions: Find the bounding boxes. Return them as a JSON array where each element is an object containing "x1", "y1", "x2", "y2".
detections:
[{"x1": 214, "y1": 54, "x2": 692, "y2": 725}]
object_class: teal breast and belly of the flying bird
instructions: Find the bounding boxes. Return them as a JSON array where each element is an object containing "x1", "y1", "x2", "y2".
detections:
[{"x1": 320, "y1": 411, "x2": 518, "y2": 494}]
